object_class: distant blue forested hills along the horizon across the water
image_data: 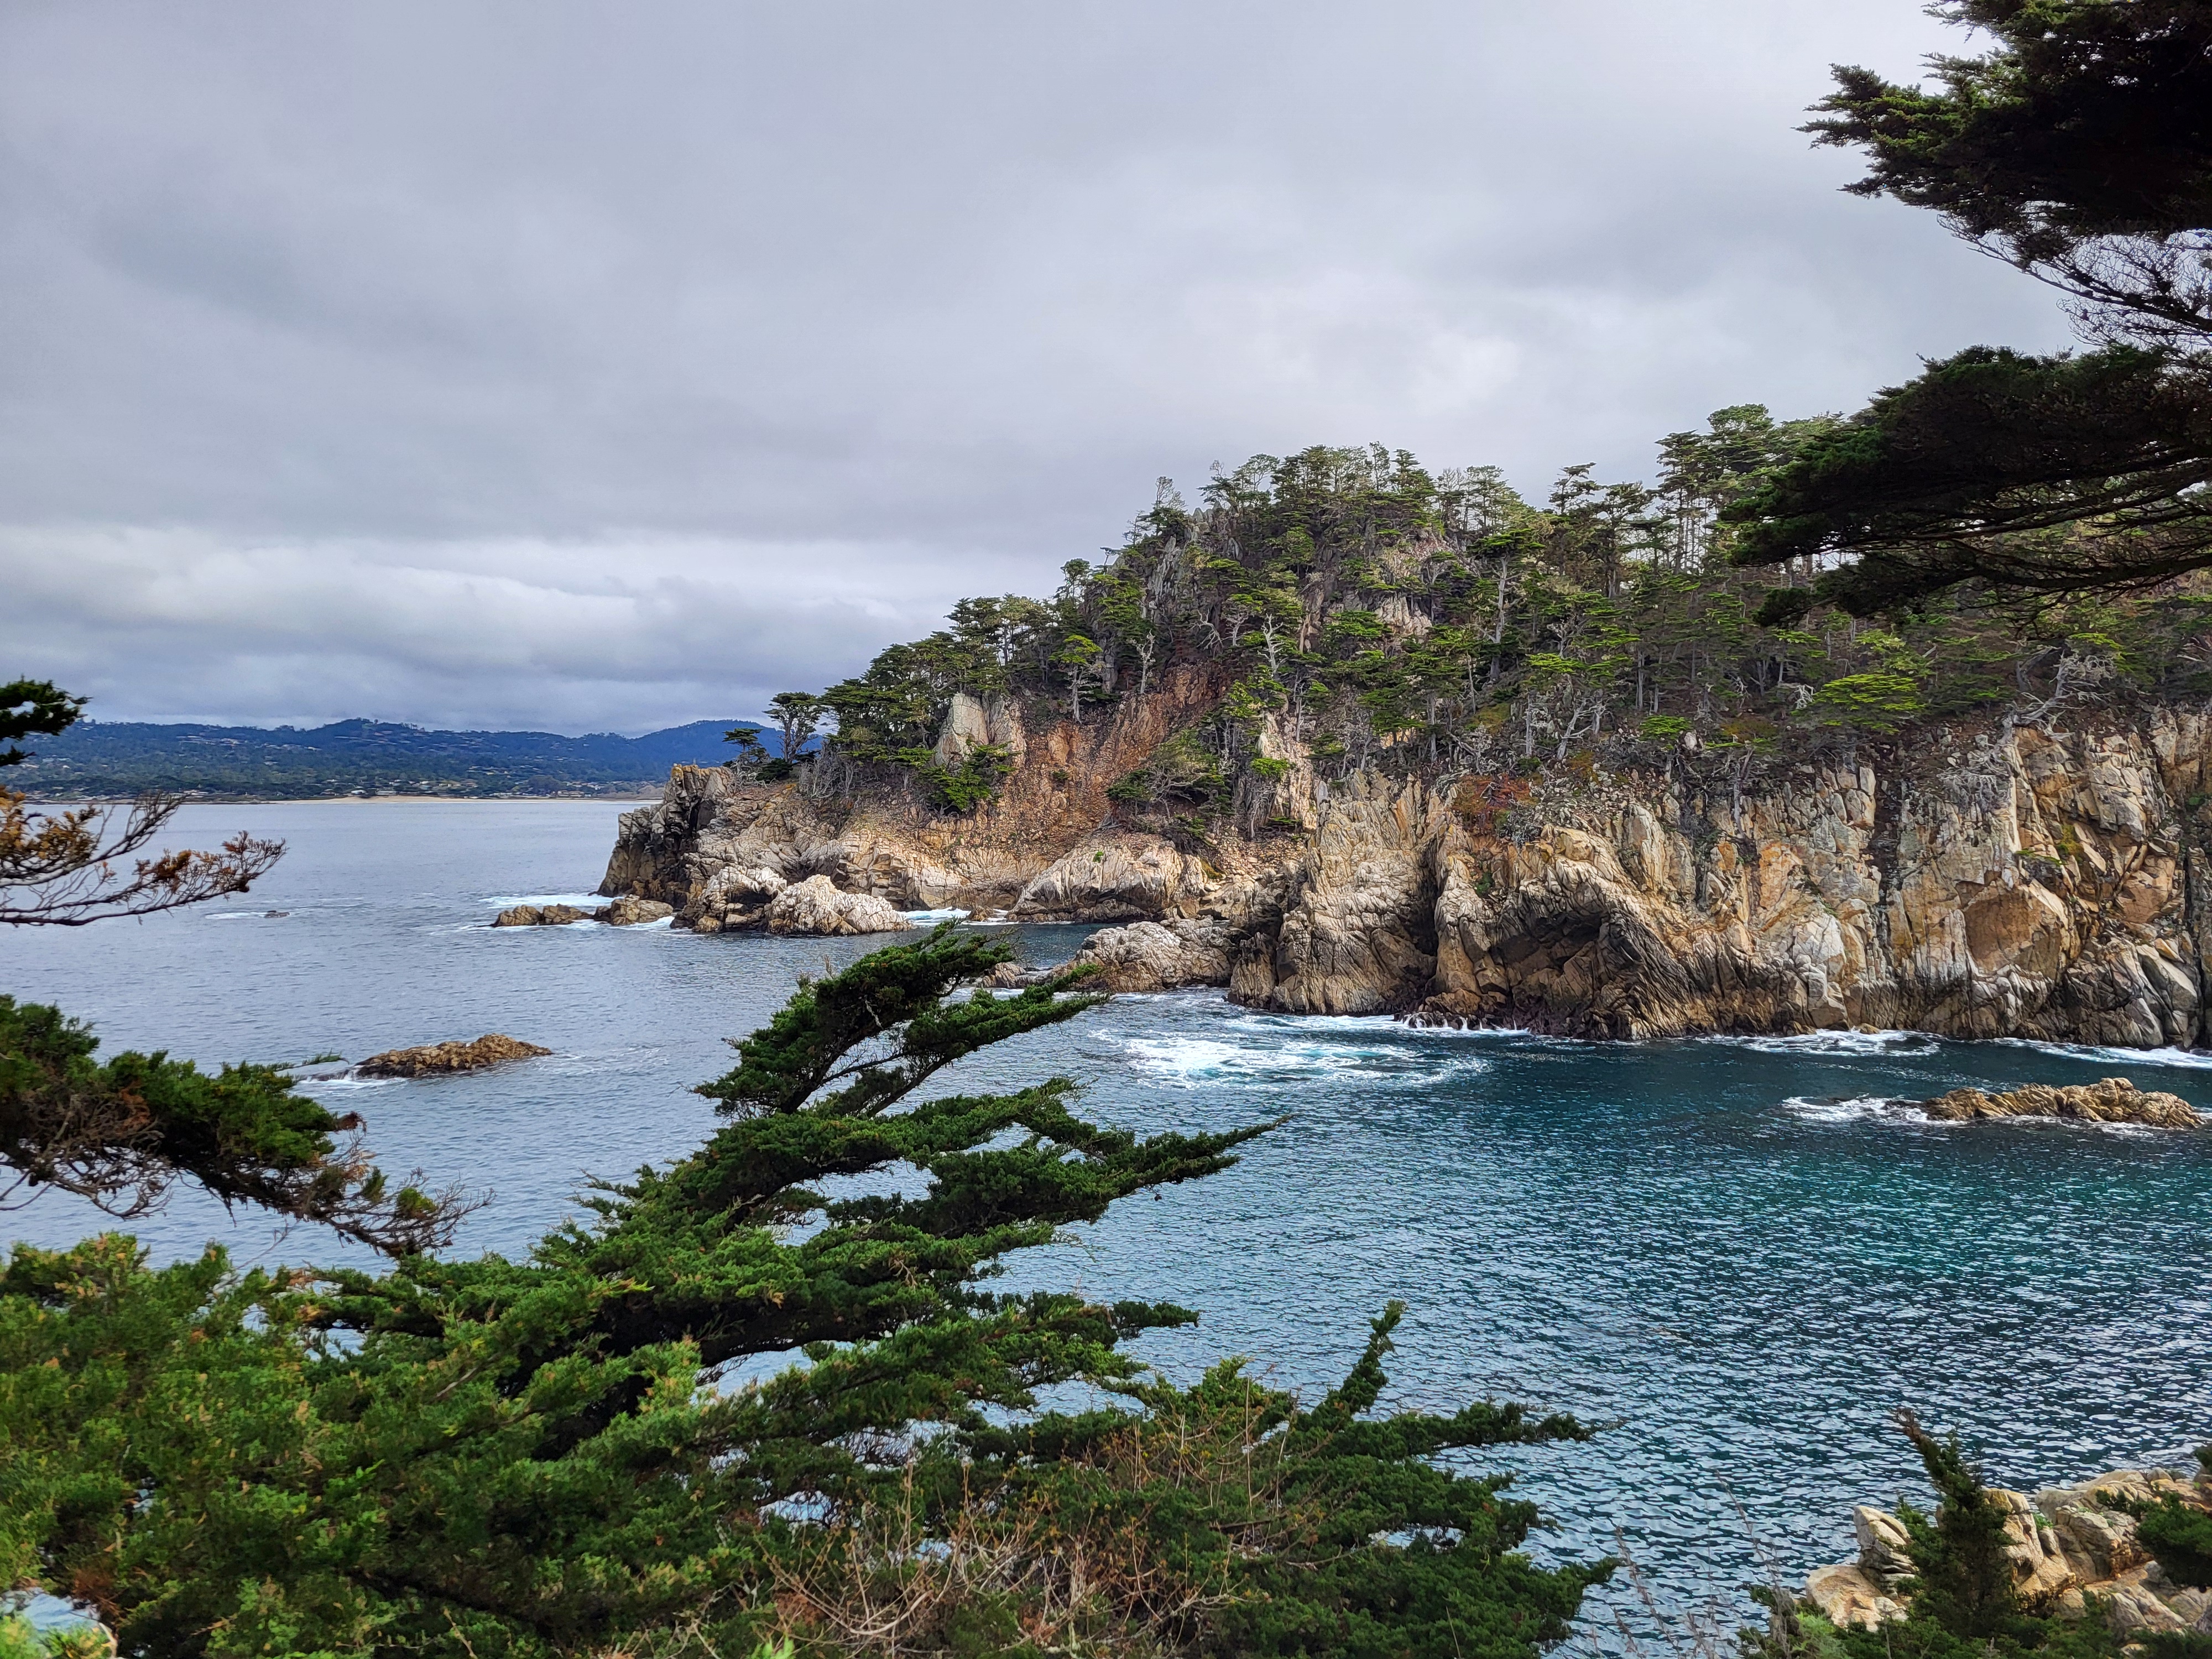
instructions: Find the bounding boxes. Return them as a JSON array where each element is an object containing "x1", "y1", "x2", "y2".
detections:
[{"x1": 9, "y1": 721, "x2": 752, "y2": 799}]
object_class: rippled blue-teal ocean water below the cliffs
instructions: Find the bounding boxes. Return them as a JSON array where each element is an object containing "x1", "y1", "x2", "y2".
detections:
[{"x1": 0, "y1": 801, "x2": 2212, "y2": 1648}]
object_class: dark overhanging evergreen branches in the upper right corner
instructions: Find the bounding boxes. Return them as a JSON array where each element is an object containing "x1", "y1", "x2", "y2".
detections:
[{"x1": 1725, "y1": 0, "x2": 2212, "y2": 615}]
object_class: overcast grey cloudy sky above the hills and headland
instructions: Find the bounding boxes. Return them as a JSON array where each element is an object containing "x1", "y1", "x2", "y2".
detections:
[{"x1": 0, "y1": 0, "x2": 2066, "y2": 732}]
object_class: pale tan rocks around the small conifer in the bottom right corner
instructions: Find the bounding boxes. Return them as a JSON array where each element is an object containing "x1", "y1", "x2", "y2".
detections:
[{"x1": 1805, "y1": 1469, "x2": 2212, "y2": 1637}]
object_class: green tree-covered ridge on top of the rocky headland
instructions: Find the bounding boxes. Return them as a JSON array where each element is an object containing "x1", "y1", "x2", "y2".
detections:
[{"x1": 783, "y1": 416, "x2": 2212, "y2": 834}]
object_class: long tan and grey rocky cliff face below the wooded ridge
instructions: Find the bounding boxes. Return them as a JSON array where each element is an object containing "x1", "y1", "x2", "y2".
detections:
[{"x1": 602, "y1": 695, "x2": 2212, "y2": 1046}]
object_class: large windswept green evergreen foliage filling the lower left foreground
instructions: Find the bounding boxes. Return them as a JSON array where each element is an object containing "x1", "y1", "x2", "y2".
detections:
[{"x1": 0, "y1": 929, "x2": 1606, "y2": 1659}]
